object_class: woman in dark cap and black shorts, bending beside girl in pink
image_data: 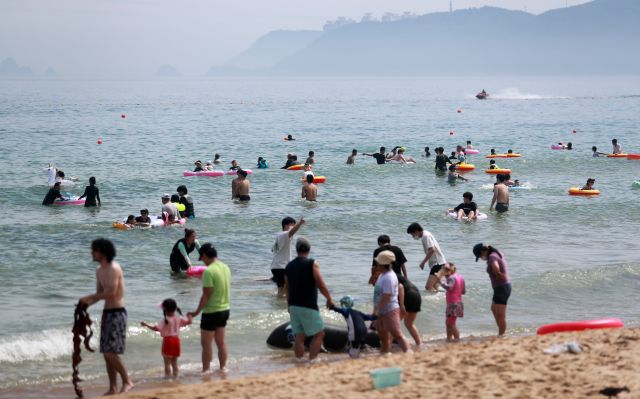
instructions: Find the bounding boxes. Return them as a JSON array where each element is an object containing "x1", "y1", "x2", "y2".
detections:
[{"x1": 473, "y1": 243, "x2": 511, "y2": 335}]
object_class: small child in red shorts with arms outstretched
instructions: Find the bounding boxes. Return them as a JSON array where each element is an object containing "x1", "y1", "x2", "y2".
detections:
[{"x1": 140, "y1": 298, "x2": 192, "y2": 378}]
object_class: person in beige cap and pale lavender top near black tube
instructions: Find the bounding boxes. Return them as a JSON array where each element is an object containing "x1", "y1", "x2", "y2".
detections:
[{"x1": 373, "y1": 251, "x2": 409, "y2": 355}]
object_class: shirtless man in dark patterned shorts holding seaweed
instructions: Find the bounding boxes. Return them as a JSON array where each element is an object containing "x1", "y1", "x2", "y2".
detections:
[{"x1": 80, "y1": 238, "x2": 133, "y2": 395}]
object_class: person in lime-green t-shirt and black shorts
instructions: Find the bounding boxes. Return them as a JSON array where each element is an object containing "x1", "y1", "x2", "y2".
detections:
[{"x1": 187, "y1": 243, "x2": 231, "y2": 373}]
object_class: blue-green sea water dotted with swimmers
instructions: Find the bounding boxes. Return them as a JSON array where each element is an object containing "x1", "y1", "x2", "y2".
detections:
[{"x1": 0, "y1": 77, "x2": 640, "y2": 397}]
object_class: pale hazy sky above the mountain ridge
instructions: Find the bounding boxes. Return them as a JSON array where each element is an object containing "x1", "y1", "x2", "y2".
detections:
[{"x1": 0, "y1": 0, "x2": 586, "y2": 76}]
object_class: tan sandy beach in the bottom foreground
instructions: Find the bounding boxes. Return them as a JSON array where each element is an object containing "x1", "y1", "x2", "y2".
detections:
[{"x1": 112, "y1": 328, "x2": 640, "y2": 399}]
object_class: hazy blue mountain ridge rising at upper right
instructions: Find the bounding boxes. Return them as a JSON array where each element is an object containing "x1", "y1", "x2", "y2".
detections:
[{"x1": 210, "y1": 0, "x2": 640, "y2": 76}]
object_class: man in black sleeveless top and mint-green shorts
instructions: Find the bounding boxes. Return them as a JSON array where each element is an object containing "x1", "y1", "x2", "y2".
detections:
[{"x1": 284, "y1": 238, "x2": 334, "y2": 361}]
